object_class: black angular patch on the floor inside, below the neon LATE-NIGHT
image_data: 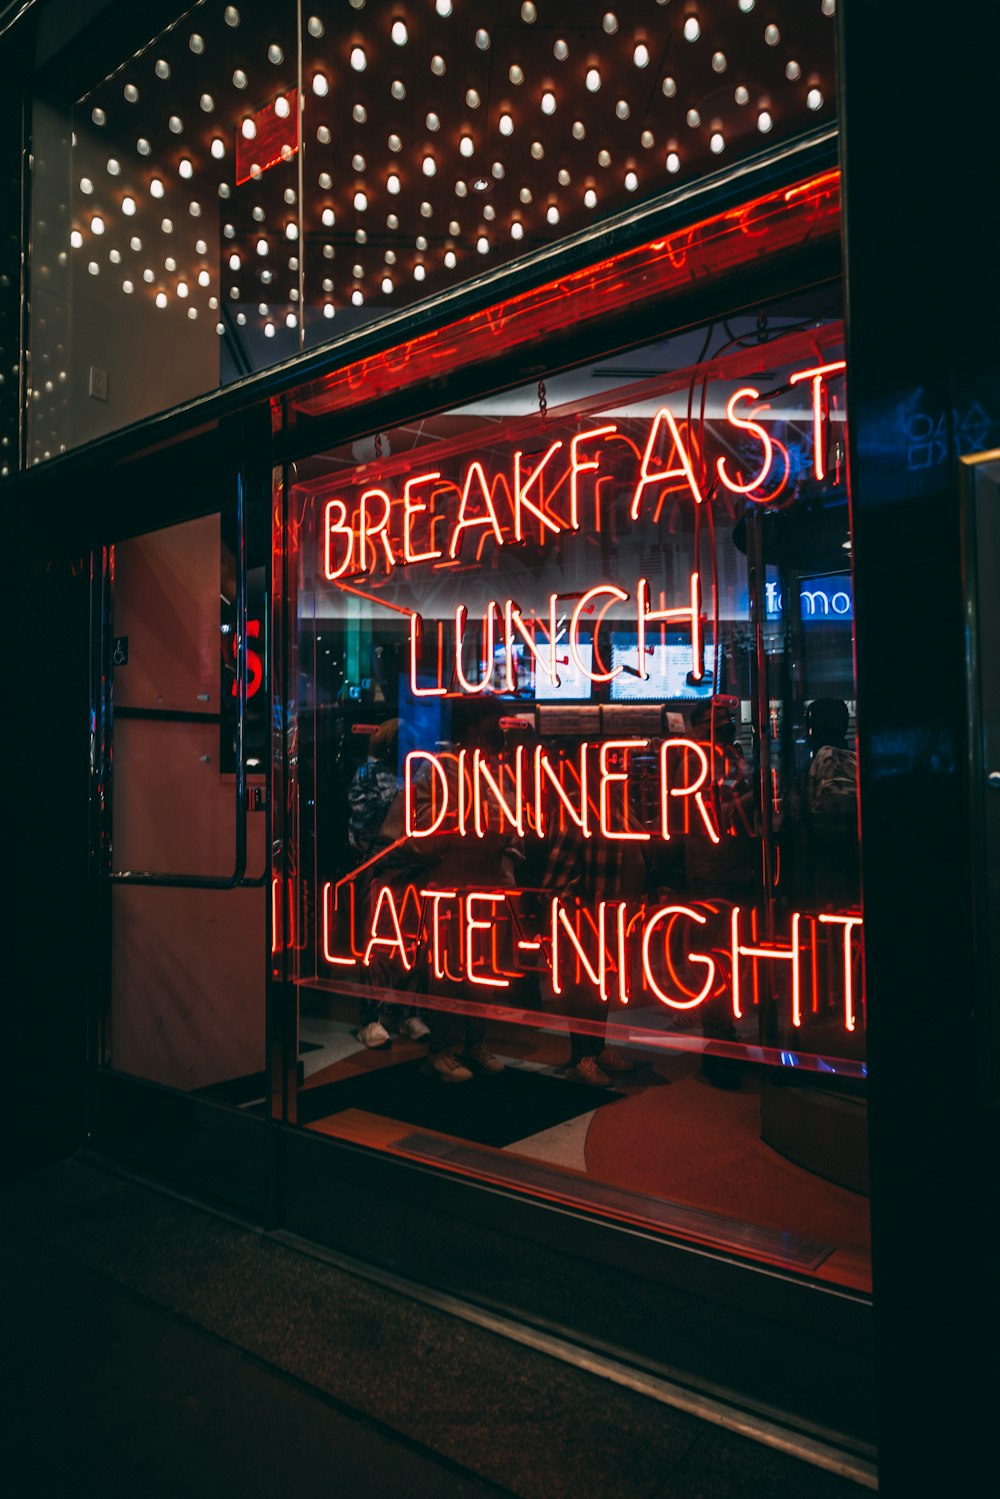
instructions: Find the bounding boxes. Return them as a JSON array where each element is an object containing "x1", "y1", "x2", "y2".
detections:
[{"x1": 298, "y1": 1061, "x2": 622, "y2": 1148}]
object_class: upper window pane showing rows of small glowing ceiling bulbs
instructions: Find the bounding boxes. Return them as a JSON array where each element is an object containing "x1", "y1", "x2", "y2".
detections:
[{"x1": 28, "y1": 0, "x2": 835, "y2": 462}]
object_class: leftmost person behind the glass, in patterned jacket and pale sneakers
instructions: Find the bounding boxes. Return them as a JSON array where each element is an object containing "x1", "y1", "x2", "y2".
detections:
[{"x1": 348, "y1": 718, "x2": 427, "y2": 1049}]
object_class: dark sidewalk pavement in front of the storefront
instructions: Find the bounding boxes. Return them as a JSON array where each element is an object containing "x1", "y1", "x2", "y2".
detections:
[{"x1": 0, "y1": 1160, "x2": 867, "y2": 1499}]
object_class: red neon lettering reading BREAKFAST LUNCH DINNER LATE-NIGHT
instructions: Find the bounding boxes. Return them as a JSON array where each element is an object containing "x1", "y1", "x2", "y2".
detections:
[{"x1": 318, "y1": 360, "x2": 864, "y2": 1031}]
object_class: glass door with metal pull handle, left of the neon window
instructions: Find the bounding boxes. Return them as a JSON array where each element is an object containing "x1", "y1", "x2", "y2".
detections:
[{"x1": 94, "y1": 458, "x2": 270, "y2": 1195}]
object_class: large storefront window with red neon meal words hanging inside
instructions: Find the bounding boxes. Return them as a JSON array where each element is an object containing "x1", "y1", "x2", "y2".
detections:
[{"x1": 283, "y1": 286, "x2": 868, "y2": 1288}]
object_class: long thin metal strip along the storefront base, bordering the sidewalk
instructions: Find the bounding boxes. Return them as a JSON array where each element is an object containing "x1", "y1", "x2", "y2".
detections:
[{"x1": 274, "y1": 1229, "x2": 879, "y2": 1490}]
